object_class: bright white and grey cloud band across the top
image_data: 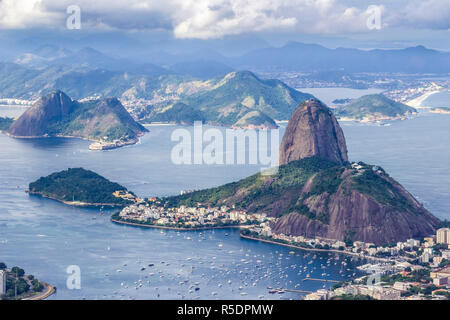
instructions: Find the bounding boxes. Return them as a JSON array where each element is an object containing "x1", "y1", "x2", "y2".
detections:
[{"x1": 0, "y1": 0, "x2": 450, "y2": 48}]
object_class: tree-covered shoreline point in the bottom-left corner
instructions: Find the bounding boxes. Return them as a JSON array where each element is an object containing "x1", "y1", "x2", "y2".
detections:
[{"x1": 0, "y1": 262, "x2": 56, "y2": 300}]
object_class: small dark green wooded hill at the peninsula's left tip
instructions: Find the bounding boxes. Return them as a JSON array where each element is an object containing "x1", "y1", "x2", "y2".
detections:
[{"x1": 28, "y1": 168, "x2": 131, "y2": 206}]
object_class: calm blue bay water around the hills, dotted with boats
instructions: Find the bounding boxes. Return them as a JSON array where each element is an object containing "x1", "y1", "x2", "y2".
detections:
[{"x1": 0, "y1": 90, "x2": 450, "y2": 299}]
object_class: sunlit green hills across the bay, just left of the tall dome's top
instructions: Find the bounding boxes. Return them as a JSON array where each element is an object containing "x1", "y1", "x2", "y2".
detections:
[{"x1": 142, "y1": 71, "x2": 312, "y2": 127}]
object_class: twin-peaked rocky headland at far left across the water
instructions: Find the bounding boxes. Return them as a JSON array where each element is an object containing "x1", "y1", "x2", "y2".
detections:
[{"x1": 7, "y1": 90, "x2": 148, "y2": 150}]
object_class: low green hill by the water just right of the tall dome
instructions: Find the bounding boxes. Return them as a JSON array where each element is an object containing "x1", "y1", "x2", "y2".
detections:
[{"x1": 334, "y1": 94, "x2": 417, "y2": 122}]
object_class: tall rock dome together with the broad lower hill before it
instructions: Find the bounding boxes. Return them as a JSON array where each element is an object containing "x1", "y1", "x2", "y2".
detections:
[{"x1": 167, "y1": 99, "x2": 439, "y2": 245}]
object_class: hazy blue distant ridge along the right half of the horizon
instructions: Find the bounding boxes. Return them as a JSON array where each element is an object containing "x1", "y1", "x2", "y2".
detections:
[{"x1": 230, "y1": 42, "x2": 450, "y2": 74}]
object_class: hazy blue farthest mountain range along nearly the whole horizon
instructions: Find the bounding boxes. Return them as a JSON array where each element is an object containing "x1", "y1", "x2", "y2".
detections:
[{"x1": 9, "y1": 42, "x2": 450, "y2": 79}]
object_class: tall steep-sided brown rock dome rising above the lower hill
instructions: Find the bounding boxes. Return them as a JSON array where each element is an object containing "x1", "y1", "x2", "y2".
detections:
[{"x1": 279, "y1": 99, "x2": 348, "y2": 165}]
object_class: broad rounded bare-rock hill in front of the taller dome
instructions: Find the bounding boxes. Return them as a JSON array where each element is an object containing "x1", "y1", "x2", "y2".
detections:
[{"x1": 273, "y1": 164, "x2": 439, "y2": 245}]
